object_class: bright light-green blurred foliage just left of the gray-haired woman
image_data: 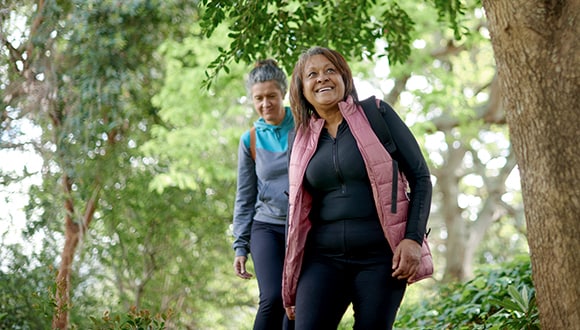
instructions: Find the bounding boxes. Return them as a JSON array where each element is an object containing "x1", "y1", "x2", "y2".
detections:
[{"x1": 141, "y1": 23, "x2": 249, "y2": 192}]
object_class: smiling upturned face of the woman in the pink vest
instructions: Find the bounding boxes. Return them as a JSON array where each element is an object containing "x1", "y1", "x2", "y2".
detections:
[{"x1": 302, "y1": 55, "x2": 345, "y2": 111}]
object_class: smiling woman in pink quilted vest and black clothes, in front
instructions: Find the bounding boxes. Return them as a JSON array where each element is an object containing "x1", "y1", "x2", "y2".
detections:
[{"x1": 282, "y1": 47, "x2": 433, "y2": 330}]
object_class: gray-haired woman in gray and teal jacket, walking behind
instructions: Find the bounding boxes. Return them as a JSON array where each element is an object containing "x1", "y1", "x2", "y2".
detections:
[{"x1": 233, "y1": 59, "x2": 294, "y2": 329}]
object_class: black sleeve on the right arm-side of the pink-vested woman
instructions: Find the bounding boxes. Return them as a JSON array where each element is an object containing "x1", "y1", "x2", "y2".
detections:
[{"x1": 381, "y1": 102, "x2": 433, "y2": 244}]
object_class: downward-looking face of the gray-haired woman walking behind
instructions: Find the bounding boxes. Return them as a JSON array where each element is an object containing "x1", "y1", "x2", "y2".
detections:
[{"x1": 251, "y1": 80, "x2": 286, "y2": 125}]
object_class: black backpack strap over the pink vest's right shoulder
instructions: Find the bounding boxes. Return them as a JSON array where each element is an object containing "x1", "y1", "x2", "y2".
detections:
[{"x1": 360, "y1": 96, "x2": 399, "y2": 213}]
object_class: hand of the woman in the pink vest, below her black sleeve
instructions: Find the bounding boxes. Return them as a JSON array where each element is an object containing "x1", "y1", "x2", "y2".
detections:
[{"x1": 393, "y1": 238, "x2": 421, "y2": 280}]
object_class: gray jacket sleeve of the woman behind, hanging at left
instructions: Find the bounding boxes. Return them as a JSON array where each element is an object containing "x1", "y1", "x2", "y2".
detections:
[{"x1": 232, "y1": 131, "x2": 258, "y2": 256}]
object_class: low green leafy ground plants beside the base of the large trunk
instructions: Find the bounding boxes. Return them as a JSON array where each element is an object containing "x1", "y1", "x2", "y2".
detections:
[{"x1": 395, "y1": 256, "x2": 539, "y2": 329}]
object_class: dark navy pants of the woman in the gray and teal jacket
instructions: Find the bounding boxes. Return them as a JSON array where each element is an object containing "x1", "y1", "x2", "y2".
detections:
[{"x1": 250, "y1": 221, "x2": 294, "y2": 330}]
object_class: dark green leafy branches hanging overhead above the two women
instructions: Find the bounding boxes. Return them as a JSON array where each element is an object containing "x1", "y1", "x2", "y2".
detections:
[{"x1": 201, "y1": 0, "x2": 463, "y2": 87}]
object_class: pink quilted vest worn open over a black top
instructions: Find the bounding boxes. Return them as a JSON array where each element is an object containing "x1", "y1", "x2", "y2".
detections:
[{"x1": 282, "y1": 97, "x2": 433, "y2": 307}]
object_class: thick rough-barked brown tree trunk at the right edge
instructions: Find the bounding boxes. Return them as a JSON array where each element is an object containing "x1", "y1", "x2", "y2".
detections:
[{"x1": 483, "y1": 0, "x2": 580, "y2": 329}]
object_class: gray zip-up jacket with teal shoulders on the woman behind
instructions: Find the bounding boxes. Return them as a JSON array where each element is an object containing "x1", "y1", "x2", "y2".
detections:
[{"x1": 232, "y1": 107, "x2": 294, "y2": 256}]
